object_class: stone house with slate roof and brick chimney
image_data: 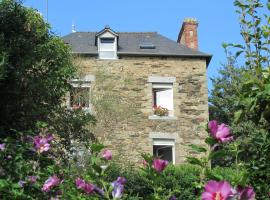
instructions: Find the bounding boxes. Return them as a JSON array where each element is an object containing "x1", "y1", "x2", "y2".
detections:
[{"x1": 63, "y1": 19, "x2": 211, "y2": 163}]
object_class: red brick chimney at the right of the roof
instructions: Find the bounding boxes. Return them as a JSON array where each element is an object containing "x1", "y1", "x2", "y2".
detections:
[{"x1": 177, "y1": 18, "x2": 198, "y2": 50}]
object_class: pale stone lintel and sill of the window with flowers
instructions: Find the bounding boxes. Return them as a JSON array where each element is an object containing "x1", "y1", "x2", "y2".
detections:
[{"x1": 148, "y1": 76, "x2": 177, "y2": 120}]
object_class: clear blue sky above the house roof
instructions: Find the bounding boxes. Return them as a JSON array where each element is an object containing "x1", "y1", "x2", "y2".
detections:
[{"x1": 24, "y1": 0, "x2": 241, "y2": 94}]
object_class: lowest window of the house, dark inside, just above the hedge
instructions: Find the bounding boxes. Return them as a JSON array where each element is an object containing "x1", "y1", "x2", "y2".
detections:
[{"x1": 153, "y1": 139, "x2": 175, "y2": 164}]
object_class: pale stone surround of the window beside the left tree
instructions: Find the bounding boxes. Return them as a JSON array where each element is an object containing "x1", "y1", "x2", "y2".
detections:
[{"x1": 67, "y1": 74, "x2": 95, "y2": 112}]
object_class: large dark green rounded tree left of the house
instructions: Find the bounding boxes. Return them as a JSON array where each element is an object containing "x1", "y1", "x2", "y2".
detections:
[{"x1": 0, "y1": 0, "x2": 75, "y2": 135}]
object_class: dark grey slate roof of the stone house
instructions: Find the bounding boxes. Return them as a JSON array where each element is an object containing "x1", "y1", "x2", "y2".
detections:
[{"x1": 62, "y1": 32, "x2": 212, "y2": 64}]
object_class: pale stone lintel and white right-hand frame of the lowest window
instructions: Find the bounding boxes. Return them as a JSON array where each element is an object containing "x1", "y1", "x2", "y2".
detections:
[{"x1": 149, "y1": 132, "x2": 180, "y2": 164}]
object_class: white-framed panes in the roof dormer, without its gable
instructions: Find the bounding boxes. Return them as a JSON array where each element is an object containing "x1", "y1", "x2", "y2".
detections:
[{"x1": 99, "y1": 37, "x2": 117, "y2": 59}]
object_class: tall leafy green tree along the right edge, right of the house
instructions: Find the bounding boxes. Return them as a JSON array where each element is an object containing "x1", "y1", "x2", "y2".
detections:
[{"x1": 210, "y1": 0, "x2": 270, "y2": 199}]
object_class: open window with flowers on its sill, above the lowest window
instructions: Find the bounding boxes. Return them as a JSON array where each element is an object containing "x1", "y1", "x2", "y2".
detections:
[{"x1": 152, "y1": 83, "x2": 173, "y2": 116}]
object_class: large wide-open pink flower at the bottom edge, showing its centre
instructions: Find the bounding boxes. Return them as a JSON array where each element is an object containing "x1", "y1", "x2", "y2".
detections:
[{"x1": 202, "y1": 181, "x2": 233, "y2": 200}]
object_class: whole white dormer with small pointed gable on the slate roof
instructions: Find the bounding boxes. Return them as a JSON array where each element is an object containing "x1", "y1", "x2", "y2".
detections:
[{"x1": 96, "y1": 27, "x2": 118, "y2": 59}]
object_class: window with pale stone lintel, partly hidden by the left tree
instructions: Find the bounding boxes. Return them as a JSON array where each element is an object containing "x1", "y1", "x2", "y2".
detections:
[{"x1": 67, "y1": 75, "x2": 94, "y2": 112}]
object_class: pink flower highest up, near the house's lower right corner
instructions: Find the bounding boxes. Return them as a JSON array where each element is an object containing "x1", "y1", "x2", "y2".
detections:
[{"x1": 208, "y1": 120, "x2": 233, "y2": 143}]
